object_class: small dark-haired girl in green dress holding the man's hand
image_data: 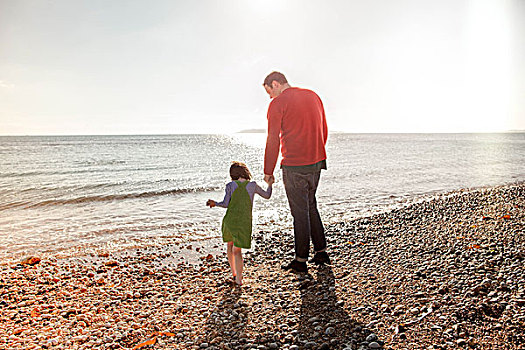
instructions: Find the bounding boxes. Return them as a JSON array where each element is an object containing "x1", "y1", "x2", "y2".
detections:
[{"x1": 206, "y1": 162, "x2": 274, "y2": 286}]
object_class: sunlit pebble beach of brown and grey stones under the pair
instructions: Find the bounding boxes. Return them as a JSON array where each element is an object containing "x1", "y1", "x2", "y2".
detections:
[{"x1": 0, "y1": 183, "x2": 525, "y2": 350}]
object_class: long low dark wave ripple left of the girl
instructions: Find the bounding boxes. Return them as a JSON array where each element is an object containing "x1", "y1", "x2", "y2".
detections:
[{"x1": 0, "y1": 187, "x2": 220, "y2": 211}]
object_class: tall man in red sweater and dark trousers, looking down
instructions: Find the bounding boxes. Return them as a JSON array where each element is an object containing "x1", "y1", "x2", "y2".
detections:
[{"x1": 263, "y1": 72, "x2": 330, "y2": 272}]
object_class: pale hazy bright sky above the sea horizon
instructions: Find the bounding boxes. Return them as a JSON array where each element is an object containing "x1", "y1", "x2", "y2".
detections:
[{"x1": 0, "y1": 0, "x2": 525, "y2": 135}]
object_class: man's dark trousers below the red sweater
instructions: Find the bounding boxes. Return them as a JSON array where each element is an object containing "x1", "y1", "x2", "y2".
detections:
[{"x1": 283, "y1": 167, "x2": 326, "y2": 261}]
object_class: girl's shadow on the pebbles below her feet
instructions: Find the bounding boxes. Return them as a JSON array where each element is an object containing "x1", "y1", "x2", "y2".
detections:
[{"x1": 203, "y1": 286, "x2": 249, "y2": 349}]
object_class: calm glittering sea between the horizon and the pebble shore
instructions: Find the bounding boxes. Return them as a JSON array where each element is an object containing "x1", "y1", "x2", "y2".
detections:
[{"x1": 0, "y1": 132, "x2": 525, "y2": 263}]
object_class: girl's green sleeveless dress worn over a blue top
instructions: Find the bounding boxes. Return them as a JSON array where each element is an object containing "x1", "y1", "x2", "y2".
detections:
[{"x1": 222, "y1": 181, "x2": 252, "y2": 248}]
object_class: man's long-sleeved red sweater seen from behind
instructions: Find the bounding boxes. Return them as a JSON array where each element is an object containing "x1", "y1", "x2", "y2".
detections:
[{"x1": 264, "y1": 87, "x2": 328, "y2": 175}]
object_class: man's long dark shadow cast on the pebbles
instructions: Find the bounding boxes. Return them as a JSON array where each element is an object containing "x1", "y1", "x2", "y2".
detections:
[{"x1": 295, "y1": 265, "x2": 366, "y2": 349}]
